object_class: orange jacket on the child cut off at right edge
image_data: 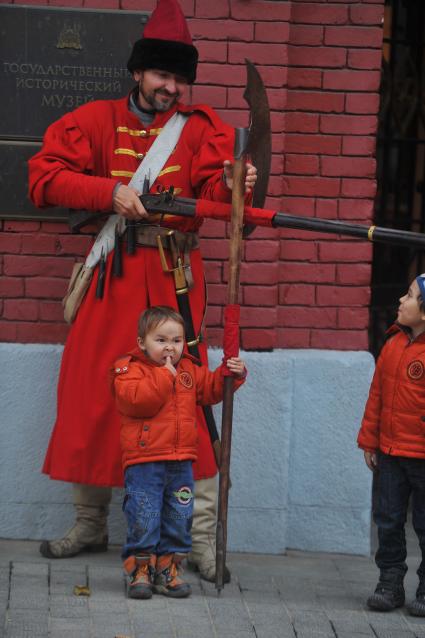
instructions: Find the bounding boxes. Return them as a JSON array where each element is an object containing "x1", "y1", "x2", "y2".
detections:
[{"x1": 357, "y1": 325, "x2": 425, "y2": 458}]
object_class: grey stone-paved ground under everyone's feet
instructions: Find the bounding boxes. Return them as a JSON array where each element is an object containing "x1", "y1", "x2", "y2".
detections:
[{"x1": 0, "y1": 541, "x2": 425, "y2": 638}]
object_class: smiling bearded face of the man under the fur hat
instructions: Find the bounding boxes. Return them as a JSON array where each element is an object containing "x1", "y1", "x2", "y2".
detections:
[{"x1": 133, "y1": 69, "x2": 188, "y2": 112}]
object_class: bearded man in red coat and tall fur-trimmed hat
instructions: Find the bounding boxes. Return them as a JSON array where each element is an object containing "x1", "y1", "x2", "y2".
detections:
[{"x1": 29, "y1": 0, "x2": 256, "y2": 580}]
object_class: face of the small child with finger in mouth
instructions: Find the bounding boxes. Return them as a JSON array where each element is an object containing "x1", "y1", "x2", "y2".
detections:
[{"x1": 137, "y1": 319, "x2": 184, "y2": 366}]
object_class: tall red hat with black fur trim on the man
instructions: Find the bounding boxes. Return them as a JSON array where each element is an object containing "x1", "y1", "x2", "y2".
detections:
[{"x1": 127, "y1": 0, "x2": 198, "y2": 84}]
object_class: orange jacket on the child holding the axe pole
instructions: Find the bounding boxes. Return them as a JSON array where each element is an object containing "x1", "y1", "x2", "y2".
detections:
[{"x1": 112, "y1": 349, "x2": 245, "y2": 470}]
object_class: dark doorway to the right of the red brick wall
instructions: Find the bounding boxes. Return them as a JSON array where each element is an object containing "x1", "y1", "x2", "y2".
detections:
[{"x1": 369, "y1": 0, "x2": 425, "y2": 356}]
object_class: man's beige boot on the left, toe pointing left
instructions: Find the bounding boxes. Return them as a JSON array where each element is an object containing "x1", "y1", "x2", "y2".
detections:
[{"x1": 40, "y1": 483, "x2": 112, "y2": 558}]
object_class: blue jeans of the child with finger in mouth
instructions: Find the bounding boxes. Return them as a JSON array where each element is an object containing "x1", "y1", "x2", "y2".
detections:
[{"x1": 121, "y1": 461, "x2": 194, "y2": 560}]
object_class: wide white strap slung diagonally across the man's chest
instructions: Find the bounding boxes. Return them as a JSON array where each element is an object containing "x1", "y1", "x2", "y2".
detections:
[{"x1": 85, "y1": 113, "x2": 189, "y2": 268}]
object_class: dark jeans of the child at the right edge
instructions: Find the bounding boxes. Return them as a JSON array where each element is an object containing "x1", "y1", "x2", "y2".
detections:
[{"x1": 373, "y1": 452, "x2": 425, "y2": 580}]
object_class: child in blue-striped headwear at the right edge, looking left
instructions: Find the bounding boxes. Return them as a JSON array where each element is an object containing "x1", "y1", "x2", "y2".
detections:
[{"x1": 358, "y1": 274, "x2": 425, "y2": 616}]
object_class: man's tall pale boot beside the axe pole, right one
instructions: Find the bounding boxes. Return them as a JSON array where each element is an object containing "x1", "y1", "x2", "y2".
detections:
[{"x1": 187, "y1": 477, "x2": 230, "y2": 583}]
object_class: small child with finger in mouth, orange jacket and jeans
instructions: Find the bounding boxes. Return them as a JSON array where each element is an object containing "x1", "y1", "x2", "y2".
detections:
[{"x1": 113, "y1": 306, "x2": 246, "y2": 598}]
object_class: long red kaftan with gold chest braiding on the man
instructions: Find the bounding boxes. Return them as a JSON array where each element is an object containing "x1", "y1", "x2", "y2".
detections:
[{"x1": 29, "y1": 98, "x2": 234, "y2": 486}]
